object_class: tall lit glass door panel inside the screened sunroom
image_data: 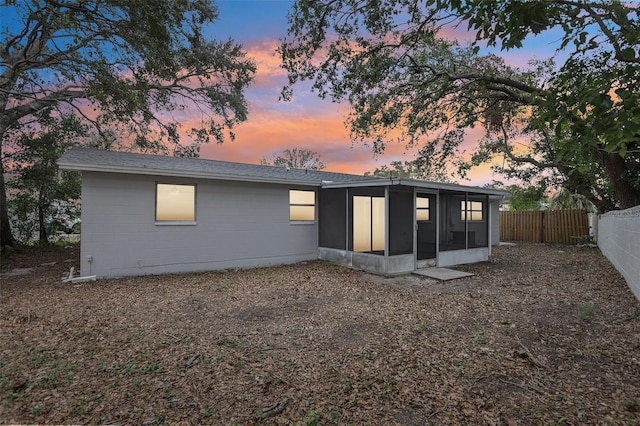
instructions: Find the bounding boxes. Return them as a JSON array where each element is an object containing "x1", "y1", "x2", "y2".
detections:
[{"x1": 353, "y1": 196, "x2": 385, "y2": 252}]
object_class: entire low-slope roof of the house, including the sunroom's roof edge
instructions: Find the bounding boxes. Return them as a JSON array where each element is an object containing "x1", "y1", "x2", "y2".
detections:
[{"x1": 58, "y1": 147, "x2": 507, "y2": 198}]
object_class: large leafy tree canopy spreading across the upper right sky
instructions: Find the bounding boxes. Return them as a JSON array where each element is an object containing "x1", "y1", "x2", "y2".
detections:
[{"x1": 280, "y1": 0, "x2": 640, "y2": 208}]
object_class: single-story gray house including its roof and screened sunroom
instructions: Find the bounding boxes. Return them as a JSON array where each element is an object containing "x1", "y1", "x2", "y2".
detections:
[{"x1": 58, "y1": 148, "x2": 506, "y2": 277}]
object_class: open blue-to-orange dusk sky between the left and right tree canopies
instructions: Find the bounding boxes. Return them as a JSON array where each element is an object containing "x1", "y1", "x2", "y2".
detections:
[{"x1": 200, "y1": 0, "x2": 554, "y2": 185}]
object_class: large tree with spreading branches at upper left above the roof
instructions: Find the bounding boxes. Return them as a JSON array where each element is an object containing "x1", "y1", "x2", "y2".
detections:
[{"x1": 0, "y1": 0, "x2": 255, "y2": 246}]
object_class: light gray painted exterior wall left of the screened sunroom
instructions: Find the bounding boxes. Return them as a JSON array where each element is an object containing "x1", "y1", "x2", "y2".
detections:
[{"x1": 80, "y1": 172, "x2": 318, "y2": 277}]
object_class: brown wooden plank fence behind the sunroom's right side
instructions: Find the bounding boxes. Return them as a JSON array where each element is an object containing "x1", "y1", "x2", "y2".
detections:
[{"x1": 500, "y1": 210, "x2": 589, "y2": 244}]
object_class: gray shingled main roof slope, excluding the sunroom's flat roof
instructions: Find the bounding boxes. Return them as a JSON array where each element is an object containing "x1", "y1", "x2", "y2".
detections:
[{"x1": 58, "y1": 148, "x2": 376, "y2": 186}]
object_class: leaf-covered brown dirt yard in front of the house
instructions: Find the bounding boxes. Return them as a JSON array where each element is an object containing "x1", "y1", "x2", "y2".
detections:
[{"x1": 0, "y1": 244, "x2": 640, "y2": 425}]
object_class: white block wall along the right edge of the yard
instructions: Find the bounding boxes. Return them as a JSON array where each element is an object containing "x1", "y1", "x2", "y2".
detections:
[{"x1": 598, "y1": 206, "x2": 640, "y2": 301}]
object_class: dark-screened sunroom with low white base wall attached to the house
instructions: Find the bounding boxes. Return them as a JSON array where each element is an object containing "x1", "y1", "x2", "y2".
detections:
[{"x1": 318, "y1": 179, "x2": 504, "y2": 275}]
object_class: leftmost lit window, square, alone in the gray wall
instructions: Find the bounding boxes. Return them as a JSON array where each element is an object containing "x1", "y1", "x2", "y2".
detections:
[{"x1": 156, "y1": 183, "x2": 196, "y2": 223}]
